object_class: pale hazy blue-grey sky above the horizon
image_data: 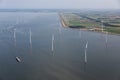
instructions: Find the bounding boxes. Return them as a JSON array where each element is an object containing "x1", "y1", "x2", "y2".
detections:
[{"x1": 0, "y1": 0, "x2": 120, "y2": 9}]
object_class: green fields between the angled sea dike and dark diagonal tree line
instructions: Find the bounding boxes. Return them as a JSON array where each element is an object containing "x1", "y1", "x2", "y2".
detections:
[{"x1": 63, "y1": 14, "x2": 101, "y2": 28}]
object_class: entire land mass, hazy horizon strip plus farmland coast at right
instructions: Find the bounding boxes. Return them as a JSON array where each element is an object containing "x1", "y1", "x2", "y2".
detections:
[{"x1": 0, "y1": 9, "x2": 120, "y2": 34}]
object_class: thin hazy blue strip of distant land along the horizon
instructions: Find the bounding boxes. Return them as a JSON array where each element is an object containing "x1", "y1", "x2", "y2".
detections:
[{"x1": 0, "y1": 9, "x2": 120, "y2": 13}]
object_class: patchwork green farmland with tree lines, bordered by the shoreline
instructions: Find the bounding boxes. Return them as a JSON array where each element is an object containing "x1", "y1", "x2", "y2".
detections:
[{"x1": 60, "y1": 12, "x2": 120, "y2": 34}]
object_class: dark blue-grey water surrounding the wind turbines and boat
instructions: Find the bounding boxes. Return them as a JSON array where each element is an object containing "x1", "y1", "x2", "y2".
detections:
[{"x1": 0, "y1": 12, "x2": 120, "y2": 80}]
